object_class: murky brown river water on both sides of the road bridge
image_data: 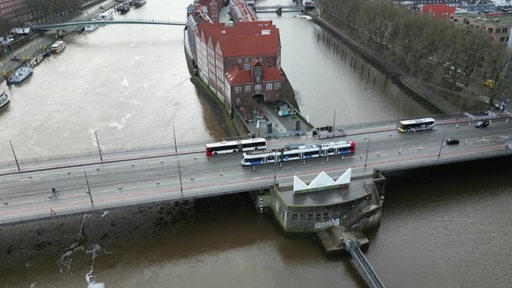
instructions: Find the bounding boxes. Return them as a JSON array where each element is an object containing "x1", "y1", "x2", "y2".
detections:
[{"x1": 0, "y1": 0, "x2": 512, "y2": 287}]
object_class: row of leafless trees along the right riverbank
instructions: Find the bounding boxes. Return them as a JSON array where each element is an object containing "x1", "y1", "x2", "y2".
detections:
[{"x1": 316, "y1": 0, "x2": 512, "y2": 106}]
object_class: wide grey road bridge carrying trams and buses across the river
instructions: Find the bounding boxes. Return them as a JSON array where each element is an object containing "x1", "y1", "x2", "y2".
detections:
[{"x1": 0, "y1": 117, "x2": 512, "y2": 226}]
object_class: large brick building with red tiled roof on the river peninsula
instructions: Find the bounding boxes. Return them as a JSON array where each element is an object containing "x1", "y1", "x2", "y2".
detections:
[{"x1": 187, "y1": 0, "x2": 287, "y2": 113}]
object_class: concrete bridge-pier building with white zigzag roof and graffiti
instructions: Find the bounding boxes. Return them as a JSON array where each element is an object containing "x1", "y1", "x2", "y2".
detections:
[{"x1": 268, "y1": 168, "x2": 385, "y2": 233}]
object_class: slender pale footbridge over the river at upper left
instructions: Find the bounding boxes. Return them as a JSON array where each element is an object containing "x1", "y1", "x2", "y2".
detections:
[{"x1": 32, "y1": 20, "x2": 186, "y2": 31}]
